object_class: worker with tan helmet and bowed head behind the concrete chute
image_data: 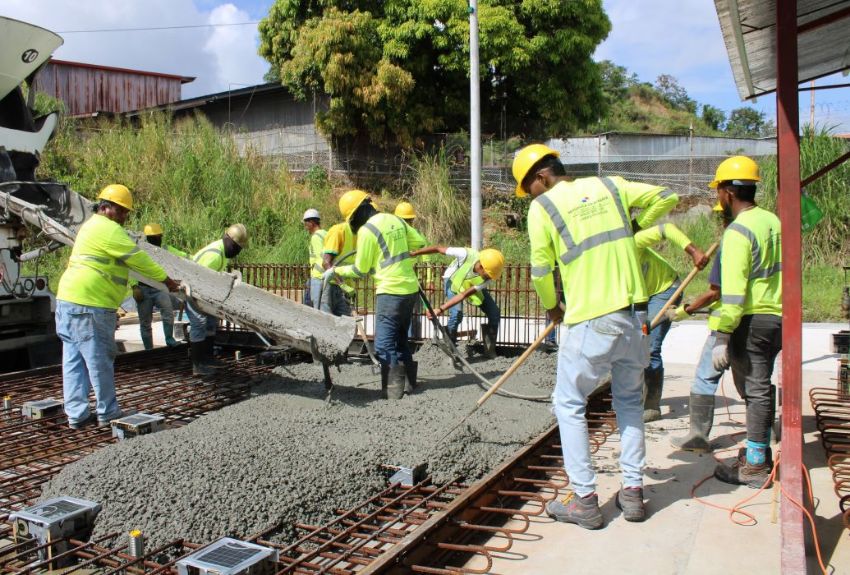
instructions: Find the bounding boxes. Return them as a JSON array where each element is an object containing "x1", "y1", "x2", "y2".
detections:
[{"x1": 186, "y1": 224, "x2": 248, "y2": 376}]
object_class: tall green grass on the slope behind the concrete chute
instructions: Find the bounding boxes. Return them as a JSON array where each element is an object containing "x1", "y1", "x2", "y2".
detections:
[{"x1": 30, "y1": 115, "x2": 336, "y2": 288}]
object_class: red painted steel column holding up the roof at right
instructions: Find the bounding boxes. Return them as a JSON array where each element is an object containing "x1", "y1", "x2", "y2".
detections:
[{"x1": 776, "y1": 0, "x2": 806, "y2": 574}]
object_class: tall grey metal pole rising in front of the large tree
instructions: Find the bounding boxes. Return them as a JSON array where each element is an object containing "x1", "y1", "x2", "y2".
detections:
[{"x1": 469, "y1": 0, "x2": 482, "y2": 250}]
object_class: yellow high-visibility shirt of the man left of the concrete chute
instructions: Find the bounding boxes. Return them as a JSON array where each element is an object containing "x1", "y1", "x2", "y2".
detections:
[{"x1": 56, "y1": 214, "x2": 167, "y2": 309}]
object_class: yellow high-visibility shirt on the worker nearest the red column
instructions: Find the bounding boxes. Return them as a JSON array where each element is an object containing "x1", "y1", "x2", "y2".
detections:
[{"x1": 717, "y1": 207, "x2": 782, "y2": 333}]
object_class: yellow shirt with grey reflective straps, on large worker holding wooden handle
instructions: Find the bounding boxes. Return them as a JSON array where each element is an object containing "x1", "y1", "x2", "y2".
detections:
[{"x1": 528, "y1": 177, "x2": 678, "y2": 324}]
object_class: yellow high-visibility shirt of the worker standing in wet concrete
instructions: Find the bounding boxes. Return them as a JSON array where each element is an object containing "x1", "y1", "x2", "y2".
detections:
[{"x1": 336, "y1": 213, "x2": 425, "y2": 295}]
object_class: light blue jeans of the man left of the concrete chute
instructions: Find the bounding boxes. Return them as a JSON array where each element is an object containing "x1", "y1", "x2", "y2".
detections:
[{"x1": 56, "y1": 300, "x2": 121, "y2": 423}]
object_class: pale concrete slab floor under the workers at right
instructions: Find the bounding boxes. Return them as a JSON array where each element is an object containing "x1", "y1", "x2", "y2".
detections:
[{"x1": 467, "y1": 363, "x2": 850, "y2": 575}]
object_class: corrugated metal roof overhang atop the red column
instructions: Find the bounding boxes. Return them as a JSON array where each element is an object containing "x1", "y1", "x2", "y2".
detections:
[{"x1": 714, "y1": 0, "x2": 850, "y2": 100}]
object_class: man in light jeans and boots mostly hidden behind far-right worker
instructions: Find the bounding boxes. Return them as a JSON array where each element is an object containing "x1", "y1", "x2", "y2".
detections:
[{"x1": 667, "y1": 203, "x2": 731, "y2": 453}]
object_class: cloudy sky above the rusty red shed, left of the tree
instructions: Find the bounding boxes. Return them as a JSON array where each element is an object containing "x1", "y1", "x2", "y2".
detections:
[{"x1": 0, "y1": 0, "x2": 267, "y2": 98}]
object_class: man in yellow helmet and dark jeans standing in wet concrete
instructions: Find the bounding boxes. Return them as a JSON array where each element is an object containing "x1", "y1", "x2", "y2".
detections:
[{"x1": 325, "y1": 190, "x2": 425, "y2": 399}]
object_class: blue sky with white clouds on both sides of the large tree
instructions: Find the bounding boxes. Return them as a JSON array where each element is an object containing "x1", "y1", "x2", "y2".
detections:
[{"x1": 0, "y1": 0, "x2": 850, "y2": 132}]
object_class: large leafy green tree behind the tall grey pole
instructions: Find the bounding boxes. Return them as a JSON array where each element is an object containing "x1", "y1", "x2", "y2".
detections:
[{"x1": 259, "y1": 0, "x2": 611, "y2": 146}]
